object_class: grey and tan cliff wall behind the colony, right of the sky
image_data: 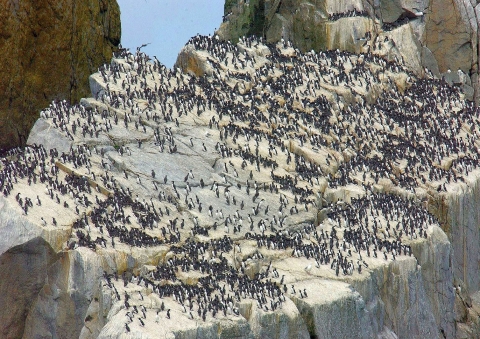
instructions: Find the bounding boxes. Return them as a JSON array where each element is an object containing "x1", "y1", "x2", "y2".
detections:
[{"x1": 218, "y1": 0, "x2": 480, "y2": 102}]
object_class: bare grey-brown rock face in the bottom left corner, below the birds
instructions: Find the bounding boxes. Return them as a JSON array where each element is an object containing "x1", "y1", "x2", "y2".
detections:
[{"x1": 0, "y1": 237, "x2": 102, "y2": 339}]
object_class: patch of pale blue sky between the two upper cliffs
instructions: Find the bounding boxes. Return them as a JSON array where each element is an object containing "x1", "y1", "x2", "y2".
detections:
[{"x1": 117, "y1": 0, "x2": 225, "y2": 68}]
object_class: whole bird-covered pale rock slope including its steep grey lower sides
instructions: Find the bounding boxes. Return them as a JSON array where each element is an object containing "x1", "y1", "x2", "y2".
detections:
[{"x1": 0, "y1": 36, "x2": 480, "y2": 338}]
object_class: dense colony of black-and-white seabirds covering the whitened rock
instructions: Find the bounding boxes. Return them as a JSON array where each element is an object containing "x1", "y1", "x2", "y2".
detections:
[{"x1": 0, "y1": 36, "x2": 480, "y2": 338}]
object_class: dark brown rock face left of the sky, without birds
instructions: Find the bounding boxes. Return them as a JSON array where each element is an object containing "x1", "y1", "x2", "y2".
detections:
[{"x1": 0, "y1": 0, "x2": 120, "y2": 148}]
